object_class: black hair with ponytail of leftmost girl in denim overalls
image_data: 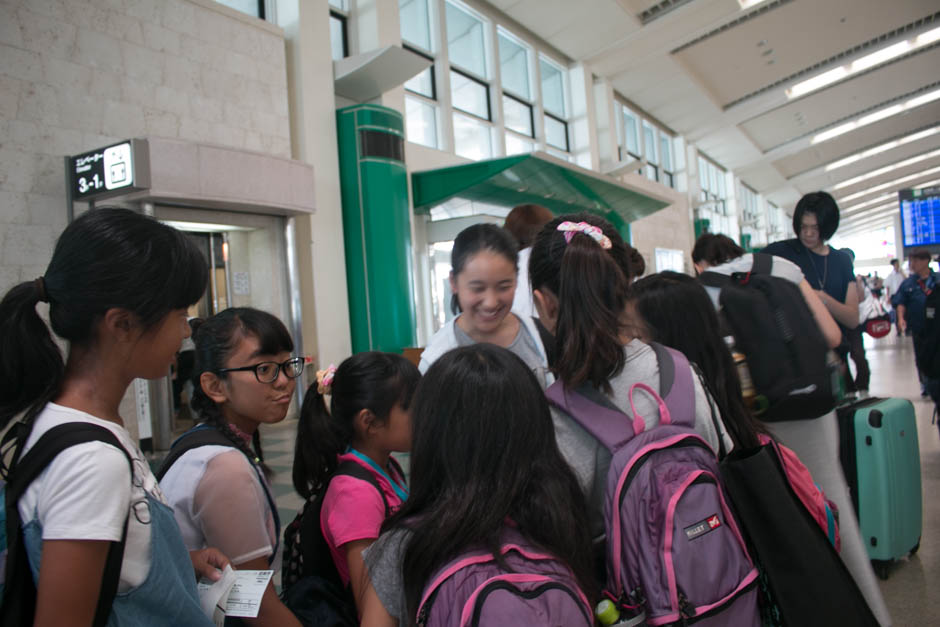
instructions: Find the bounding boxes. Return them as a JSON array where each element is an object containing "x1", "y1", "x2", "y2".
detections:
[{"x1": 0, "y1": 208, "x2": 208, "y2": 429}]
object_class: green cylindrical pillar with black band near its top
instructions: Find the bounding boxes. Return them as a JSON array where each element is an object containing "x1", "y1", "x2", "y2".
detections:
[{"x1": 336, "y1": 105, "x2": 415, "y2": 353}]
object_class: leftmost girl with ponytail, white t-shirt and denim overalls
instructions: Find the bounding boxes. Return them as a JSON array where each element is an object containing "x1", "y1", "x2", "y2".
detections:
[{"x1": 0, "y1": 208, "x2": 227, "y2": 626}]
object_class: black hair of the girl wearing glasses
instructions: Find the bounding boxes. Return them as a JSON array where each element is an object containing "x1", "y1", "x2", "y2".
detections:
[{"x1": 190, "y1": 307, "x2": 294, "y2": 474}]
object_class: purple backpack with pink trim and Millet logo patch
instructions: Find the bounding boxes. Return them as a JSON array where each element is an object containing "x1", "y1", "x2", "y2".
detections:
[{"x1": 546, "y1": 344, "x2": 760, "y2": 627}]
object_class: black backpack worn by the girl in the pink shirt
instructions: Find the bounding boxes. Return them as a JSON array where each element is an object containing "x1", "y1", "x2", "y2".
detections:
[{"x1": 281, "y1": 458, "x2": 396, "y2": 627}]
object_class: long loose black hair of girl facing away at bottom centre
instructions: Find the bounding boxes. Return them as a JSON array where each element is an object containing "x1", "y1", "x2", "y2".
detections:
[{"x1": 385, "y1": 343, "x2": 594, "y2": 616}]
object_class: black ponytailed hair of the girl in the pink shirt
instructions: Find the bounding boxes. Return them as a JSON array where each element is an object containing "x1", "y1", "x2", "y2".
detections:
[{"x1": 293, "y1": 351, "x2": 421, "y2": 499}]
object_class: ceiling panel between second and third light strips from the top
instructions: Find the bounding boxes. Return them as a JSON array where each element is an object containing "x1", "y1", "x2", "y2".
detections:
[{"x1": 774, "y1": 101, "x2": 940, "y2": 178}]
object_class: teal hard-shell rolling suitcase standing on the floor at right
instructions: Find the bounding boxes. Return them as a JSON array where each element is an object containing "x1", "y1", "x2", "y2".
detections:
[{"x1": 838, "y1": 398, "x2": 922, "y2": 579}]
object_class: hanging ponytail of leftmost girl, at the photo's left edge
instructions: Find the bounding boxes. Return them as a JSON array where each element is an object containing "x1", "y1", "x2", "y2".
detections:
[{"x1": 0, "y1": 278, "x2": 65, "y2": 429}]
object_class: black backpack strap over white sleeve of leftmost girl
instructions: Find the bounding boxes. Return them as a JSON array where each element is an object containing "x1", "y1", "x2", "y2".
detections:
[{"x1": 0, "y1": 422, "x2": 134, "y2": 627}]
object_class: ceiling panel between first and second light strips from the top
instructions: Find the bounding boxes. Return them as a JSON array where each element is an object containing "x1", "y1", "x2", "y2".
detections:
[{"x1": 741, "y1": 47, "x2": 940, "y2": 152}]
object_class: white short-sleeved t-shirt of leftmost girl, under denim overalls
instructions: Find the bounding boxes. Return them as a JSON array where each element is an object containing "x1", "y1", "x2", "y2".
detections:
[{"x1": 19, "y1": 403, "x2": 166, "y2": 592}]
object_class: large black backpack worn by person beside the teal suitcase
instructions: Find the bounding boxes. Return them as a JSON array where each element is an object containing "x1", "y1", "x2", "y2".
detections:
[{"x1": 699, "y1": 253, "x2": 838, "y2": 422}]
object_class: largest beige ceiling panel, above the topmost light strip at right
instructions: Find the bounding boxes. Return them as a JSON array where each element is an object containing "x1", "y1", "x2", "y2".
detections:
[{"x1": 674, "y1": 0, "x2": 936, "y2": 106}]
